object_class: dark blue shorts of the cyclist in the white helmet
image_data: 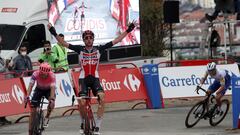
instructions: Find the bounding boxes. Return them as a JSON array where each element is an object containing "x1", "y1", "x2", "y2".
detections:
[{"x1": 208, "y1": 74, "x2": 231, "y2": 95}]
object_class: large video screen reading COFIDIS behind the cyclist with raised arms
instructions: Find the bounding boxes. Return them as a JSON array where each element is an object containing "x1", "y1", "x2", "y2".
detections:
[{"x1": 48, "y1": 0, "x2": 140, "y2": 46}]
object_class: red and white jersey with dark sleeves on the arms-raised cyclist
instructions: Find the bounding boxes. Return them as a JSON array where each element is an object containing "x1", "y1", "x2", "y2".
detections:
[{"x1": 68, "y1": 42, "x2": 113, "y2": 79}]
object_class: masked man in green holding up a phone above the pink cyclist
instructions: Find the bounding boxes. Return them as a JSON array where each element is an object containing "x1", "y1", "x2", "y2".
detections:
[{"x1": 38, "y1": 41, "x2": 59, "y2": 68}]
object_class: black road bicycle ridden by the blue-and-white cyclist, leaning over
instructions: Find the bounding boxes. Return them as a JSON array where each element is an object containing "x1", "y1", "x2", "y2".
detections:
[{"x1": 185, "y1": 86, "x2": 229, "y2": 128}]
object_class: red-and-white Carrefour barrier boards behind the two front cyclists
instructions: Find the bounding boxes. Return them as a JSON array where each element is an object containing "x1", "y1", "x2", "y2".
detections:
[{"x1": 0, "y1": 63, "x2": 151, "y2": 121}]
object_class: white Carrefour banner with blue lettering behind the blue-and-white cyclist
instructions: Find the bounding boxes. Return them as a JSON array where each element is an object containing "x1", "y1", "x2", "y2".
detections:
[{"x1": 159, "y1": 64, "x2": 239, "y2": 98}]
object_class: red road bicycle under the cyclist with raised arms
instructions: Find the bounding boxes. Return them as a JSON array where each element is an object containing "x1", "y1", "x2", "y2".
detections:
[{"x1": 72, "y1": 90, "x2": 99, "y2": 135}]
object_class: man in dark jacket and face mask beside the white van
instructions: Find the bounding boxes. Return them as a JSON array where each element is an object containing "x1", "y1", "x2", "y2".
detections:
[{"x1": 9, "y1": 42, "x2": 33, "y2": 75}]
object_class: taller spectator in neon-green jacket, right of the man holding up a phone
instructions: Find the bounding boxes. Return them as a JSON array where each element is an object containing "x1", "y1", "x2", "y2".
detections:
[{"x1": 52, "y1": 33, "x2": 69, "y2": 72}]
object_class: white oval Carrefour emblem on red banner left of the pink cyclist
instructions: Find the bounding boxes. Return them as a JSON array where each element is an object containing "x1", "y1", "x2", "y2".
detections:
[{"x1": 12, "y1": 85, "x2": 24, "y2": 104}]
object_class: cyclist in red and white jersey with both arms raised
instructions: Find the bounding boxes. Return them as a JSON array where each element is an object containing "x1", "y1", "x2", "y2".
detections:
[{"x1": 48, "y1": 22, "x2": 135, "y2": 134}]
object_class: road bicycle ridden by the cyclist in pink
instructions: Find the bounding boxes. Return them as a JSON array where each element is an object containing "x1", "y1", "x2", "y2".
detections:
[{"x1": 25, "y1": 97, "x2": 48, "y2": 135}]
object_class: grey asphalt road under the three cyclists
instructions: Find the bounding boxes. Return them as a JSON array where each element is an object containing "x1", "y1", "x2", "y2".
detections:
[{"x1": 0, "y1": 107, "x2": 240, "y2": 135}]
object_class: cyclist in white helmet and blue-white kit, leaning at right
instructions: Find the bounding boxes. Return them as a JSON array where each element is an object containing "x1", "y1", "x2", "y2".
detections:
[{"x1": 200, "y1": 62, "x2": 231, "y2": 109}]
